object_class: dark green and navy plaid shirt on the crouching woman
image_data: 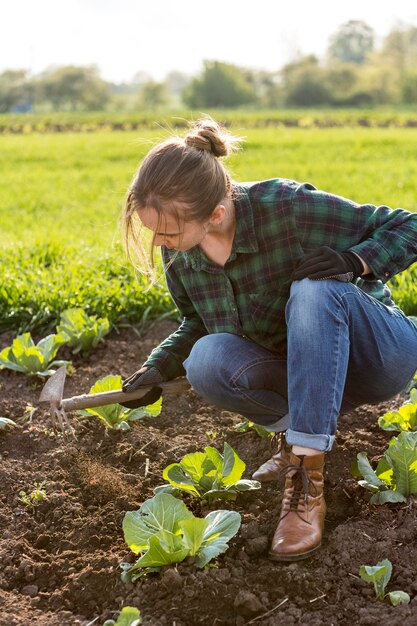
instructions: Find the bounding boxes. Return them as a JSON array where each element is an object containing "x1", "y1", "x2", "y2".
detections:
[{"x1": 145, "y1": 179, "x2": 417, "y2": 378}]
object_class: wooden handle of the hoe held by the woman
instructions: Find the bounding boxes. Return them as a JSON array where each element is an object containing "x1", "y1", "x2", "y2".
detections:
[{"x1": 60, "y1": 378, "x2": 191, "y2": 411}]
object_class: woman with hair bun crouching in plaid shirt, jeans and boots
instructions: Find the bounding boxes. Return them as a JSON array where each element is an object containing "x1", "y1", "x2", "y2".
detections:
[{"x1": 119, "y1": 119, "x2": 417, "y2": 561}]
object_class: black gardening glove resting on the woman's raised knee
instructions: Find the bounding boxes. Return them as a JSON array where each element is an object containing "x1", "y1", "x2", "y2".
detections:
[{"x1": 292, "y1": 246, "x2": 364, "y2": 282}]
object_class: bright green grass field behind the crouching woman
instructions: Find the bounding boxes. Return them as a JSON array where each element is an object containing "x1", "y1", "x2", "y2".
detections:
[{"x1": 0, "y1": 118, "x2": 417, "y2": 331}]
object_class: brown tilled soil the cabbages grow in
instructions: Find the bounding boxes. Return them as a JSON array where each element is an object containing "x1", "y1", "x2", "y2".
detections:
[{"x1": 0, "y1": 321, "x2": 417, "y2": 626}]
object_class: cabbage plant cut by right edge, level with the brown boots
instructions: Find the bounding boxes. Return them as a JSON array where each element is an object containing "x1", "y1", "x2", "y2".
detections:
[{"x1": 353, "y1": 431, "x2": 417, "y2": 504}]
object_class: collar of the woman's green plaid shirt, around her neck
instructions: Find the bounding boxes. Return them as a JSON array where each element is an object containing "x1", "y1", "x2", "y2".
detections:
[{"x1": 182, "y1": 179, "x2": 259, "y2": 272}]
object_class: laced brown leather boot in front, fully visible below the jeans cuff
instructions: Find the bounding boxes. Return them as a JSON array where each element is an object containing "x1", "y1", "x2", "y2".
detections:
[{"x1": 269, "y1": 452, "x2": 326, "y2": 561}]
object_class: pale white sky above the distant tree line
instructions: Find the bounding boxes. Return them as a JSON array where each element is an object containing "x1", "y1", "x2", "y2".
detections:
[{"x1": 0, "y1": 0, "x2": 417, "y2": 83}]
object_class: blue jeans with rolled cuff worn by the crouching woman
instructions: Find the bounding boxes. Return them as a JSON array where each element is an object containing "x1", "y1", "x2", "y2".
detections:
[{"x1": 184, "y1": 278, "x2": 417, "y2": 452}]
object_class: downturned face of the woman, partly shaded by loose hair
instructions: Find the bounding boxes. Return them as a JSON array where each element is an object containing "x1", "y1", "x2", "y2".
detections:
[{"x1": 138, "y1": 208, "x2": 209, "y2": 252}]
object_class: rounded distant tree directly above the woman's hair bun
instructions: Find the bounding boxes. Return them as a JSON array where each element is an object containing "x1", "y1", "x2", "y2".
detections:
[{"x1": 182, "y1": 61, "x2": 257, "y2": 108}]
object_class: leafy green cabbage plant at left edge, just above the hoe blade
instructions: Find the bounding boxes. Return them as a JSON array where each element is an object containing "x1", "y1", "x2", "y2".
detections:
[{"x1": 0, "y1": 333, "x2": 70, "y2": 376}]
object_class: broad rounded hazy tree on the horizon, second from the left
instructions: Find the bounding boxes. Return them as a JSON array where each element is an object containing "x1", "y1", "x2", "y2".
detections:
[{"x1": 39, "y1": 65, "x2": 109, "y2": 111}]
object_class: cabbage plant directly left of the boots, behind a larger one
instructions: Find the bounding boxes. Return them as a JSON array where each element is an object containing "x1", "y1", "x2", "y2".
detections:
[{"x1": 155, "y1": 443, "x2": 261, "y2": 504}]
